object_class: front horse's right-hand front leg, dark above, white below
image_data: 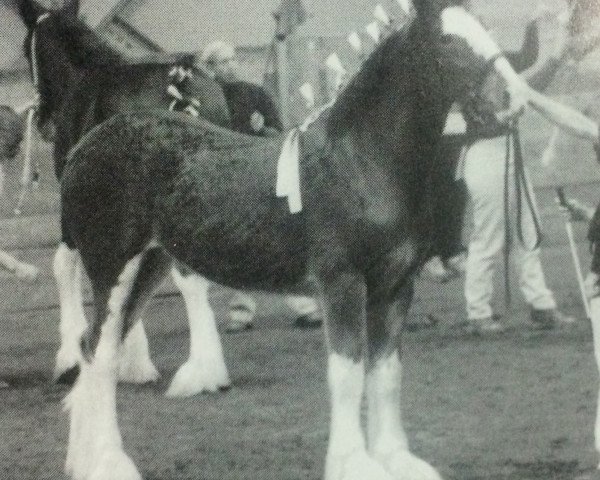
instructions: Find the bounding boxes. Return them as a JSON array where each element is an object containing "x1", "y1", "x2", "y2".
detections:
[{"x1": 367, "y1": 280, "x2": 441, "y2": 480}]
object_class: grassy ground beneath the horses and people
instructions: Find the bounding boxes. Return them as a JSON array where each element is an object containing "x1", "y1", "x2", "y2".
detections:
[{"x1": 0, "y1": 294, "x2": 598, "y2": 480}]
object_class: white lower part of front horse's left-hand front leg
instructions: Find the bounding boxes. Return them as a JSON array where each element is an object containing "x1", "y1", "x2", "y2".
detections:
[{"x1": 325, "y1": 353, "x2": 393, "y2": 480}]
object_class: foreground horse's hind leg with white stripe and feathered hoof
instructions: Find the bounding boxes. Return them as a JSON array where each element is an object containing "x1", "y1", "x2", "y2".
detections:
[{"x1": 66, "y1": 249, "x2": 170, "y2": 480}]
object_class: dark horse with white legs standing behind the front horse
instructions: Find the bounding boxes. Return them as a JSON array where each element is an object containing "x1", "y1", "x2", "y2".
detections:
[{"x1": 19, "y1": 0, "x2": 236, "y2": 396}]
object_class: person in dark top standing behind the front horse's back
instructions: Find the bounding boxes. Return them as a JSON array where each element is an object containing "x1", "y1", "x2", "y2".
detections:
[{"x1": 200, "y1": 40, "x2": 322, "y2": 333}]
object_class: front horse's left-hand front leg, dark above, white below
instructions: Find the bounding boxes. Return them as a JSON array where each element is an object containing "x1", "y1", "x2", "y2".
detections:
[{"x1": 321, "y1": 273, "x2": 392, "y2": 480}]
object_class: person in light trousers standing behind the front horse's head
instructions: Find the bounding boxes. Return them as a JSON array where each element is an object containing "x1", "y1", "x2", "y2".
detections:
[{"x1": 462, "y1": 4, "x2": 574, "y2": 334}]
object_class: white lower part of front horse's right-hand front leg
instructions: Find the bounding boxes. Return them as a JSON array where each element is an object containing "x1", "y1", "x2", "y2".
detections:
[{"x1": 367, "y1": 352, "x2": 441, "y2": 480}]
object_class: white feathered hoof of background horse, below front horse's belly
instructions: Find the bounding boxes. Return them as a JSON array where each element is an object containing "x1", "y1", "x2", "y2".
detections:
[{"x1": 165, "y1": 360, "x2": 231, "y2": 398}]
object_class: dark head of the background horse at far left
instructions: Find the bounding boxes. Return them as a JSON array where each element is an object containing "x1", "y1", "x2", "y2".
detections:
[{"x1": 19, "y1": 0, "x2": 79, "y2": 139}]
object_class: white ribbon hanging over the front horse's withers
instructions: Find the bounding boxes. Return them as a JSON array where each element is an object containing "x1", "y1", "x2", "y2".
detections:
[{"x1": 275, "y1": 100, "x2": 333, "y2": 213}]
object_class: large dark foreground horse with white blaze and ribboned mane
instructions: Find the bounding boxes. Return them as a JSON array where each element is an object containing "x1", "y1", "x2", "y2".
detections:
[{"x1": 55, "y1": 0, "x2": 556, "y2": 480}]
